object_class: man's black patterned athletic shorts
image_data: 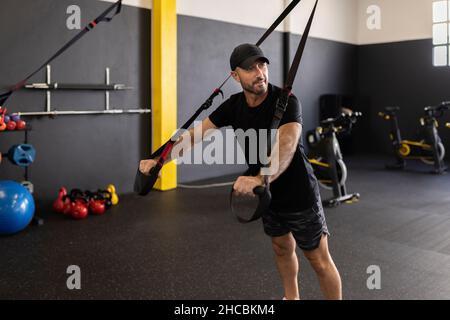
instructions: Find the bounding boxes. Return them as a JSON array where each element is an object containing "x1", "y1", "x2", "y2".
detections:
[{"x1": 262, "y1": 201, "x2": 329, "y2": 250}]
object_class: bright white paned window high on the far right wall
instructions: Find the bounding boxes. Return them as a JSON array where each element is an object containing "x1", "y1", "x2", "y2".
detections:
[{"x1": 433, "y1": 0, "x2": 450, "y2": 67}]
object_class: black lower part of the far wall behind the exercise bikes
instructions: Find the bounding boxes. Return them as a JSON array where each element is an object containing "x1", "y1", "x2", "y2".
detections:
[{"x1": 357, "y1": 39, "x2": 450, "y2": 153}]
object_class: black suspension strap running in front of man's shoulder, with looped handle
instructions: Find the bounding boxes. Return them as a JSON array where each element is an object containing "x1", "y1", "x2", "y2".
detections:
[{"x1": 230, "y1": 0, "x2": 318, "y2": 223}]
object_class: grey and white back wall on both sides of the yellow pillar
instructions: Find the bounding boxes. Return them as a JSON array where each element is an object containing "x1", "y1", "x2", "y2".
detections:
[{"x1": 0, "y1": 0, "x2": 357, "y2": 199}]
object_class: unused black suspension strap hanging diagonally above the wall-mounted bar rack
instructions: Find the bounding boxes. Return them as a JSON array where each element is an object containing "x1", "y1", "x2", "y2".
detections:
[{"x1": 0, "y1": 0, "x2": 122, "y2": 106}]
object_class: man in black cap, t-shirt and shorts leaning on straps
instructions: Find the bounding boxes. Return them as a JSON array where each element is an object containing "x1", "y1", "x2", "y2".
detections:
[{"x1": 140, "y1": 44, "x2": 342, "y2": 300}]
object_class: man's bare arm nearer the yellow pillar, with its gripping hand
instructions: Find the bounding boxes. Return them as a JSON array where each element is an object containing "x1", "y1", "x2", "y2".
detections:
[{"x1": 139, "y1": 118, "x2": 217, "y2": 174}]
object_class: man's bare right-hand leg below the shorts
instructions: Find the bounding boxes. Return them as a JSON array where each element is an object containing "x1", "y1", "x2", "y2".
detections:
[{"x1": 303, "y1": 235, "x2": 342, "y2": 300}]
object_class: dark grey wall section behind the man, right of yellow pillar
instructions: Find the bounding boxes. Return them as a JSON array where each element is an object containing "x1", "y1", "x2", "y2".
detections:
[{"x1": 178, "y1": 16, "x2": 356, "y2": 182}]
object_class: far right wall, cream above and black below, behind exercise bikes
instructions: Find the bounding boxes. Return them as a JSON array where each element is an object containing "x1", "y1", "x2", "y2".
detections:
[{"x1": 357, "y1": 0, "x2": 450, "y2": 153}]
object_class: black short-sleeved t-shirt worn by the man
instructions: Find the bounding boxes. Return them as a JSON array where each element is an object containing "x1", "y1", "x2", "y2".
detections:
[{"x1": 209, "y1": 84, "x2": 320, "y2": 212}]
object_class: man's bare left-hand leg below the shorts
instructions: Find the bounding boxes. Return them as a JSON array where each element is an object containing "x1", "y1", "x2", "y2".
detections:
[{"x1": 272, "y1": 233, "x2": 300, "y2": 300}]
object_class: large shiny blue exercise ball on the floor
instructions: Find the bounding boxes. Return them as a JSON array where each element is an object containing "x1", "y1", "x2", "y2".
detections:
[{"x1": 0, "y1": 180, "x2": 35, "y2": 235}]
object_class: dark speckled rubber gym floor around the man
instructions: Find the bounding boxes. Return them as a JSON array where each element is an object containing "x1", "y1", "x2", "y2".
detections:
[{"x1": 0, "y1": 157, "x2": 450, "y2": 300}]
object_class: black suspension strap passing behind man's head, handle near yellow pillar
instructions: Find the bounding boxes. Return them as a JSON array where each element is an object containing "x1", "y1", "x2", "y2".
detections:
[{"x1": 134, "y1": 0, "x2": 301, "y2": 196}]
